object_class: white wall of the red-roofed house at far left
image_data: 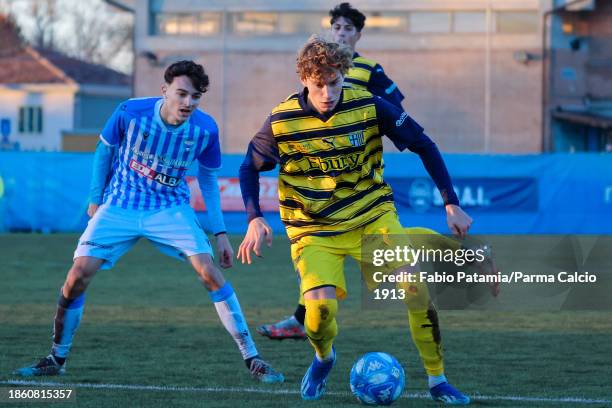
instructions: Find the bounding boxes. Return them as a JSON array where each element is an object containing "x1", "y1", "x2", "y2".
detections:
[{"x1": 0, "y1": 85, "x2": 77, "y2": 151}]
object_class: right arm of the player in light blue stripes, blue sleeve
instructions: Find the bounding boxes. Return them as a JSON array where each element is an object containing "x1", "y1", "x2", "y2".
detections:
[{"x1": 198, "y1": 125, "x2": 234, "y2": 268}]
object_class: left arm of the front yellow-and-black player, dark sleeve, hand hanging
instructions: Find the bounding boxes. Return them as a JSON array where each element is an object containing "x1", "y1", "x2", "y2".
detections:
[{"x1": 237, "y1": 117, "x2": 280, "y2": 264}]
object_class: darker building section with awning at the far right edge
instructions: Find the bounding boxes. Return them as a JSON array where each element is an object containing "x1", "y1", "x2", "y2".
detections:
[{"x1": 542, "y1": 0, "x2": 612, "y2": 152}]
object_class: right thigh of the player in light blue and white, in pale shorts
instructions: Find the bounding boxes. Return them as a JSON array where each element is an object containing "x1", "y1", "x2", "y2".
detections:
[{"x1": 143, "y1": 204, "x2": 214, "y2": 260}]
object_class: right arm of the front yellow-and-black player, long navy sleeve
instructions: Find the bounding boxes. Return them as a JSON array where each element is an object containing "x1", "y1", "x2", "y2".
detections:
[{"x1": 375, "y1": 98, "x2": 472, "y2": 237}]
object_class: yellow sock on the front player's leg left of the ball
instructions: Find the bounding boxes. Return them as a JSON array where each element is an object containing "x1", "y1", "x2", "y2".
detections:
[{"x1": 304, "y1": 299, "x2": 338, "y2": 359}]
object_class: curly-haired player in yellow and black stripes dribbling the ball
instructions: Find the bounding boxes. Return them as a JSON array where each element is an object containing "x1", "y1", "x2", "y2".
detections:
[{"x1": 238, "y1": 37, "x2": 472, "y2": 404}]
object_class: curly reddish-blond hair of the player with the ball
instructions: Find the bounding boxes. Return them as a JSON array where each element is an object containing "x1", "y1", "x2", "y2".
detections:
[{"x1": 297, "y1": 35, "x2": 353, "y2": 80}]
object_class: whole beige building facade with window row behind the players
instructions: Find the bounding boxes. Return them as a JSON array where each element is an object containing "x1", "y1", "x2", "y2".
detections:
[{"x1": 123, "y1": 0, "x2": 550, "y2": 153}]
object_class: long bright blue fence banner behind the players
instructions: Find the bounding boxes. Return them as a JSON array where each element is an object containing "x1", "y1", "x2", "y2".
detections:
[{"x1": 0, "y1": 152, "x2": 612, "y2": 234}]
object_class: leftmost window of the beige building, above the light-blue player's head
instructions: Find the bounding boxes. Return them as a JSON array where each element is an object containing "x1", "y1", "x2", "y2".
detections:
[{"x1": 155, "y1": 13, "x2": 222, "y2": 37}]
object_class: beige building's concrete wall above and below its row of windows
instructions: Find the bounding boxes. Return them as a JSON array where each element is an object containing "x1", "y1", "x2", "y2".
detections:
[{"x1": 134, "y1": 0, "x2": 550, "y2": 153}]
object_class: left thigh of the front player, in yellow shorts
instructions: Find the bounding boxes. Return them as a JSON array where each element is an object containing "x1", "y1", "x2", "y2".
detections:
[{"x1": 291, "y1": 236, "x2": 347, "y2": 299}]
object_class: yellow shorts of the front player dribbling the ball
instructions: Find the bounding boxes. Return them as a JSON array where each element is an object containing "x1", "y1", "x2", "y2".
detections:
[{"x1": 291, "y1": 211, "x2": 404, "y2": 299}]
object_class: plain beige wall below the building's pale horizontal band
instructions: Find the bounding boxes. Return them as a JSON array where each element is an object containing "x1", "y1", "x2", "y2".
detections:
[{"x1": 135, "y1": 43, "x2": 541, "y2": 153}]
